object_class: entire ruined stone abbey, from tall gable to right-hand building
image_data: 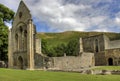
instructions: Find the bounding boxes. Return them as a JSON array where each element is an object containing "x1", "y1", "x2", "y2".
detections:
[{"x1": 8, "y1": 1, "x2": 120, "y2": 70}]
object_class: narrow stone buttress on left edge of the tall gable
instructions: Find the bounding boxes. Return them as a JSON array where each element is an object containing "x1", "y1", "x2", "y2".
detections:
[{"x1": 8, "y1": 29, "x2": 13, "y2": 68}]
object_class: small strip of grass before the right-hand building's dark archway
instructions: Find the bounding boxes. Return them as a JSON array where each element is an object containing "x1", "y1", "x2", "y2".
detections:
[{"x1": 93, "y1": 66, "x2": 120, "y2": 70}]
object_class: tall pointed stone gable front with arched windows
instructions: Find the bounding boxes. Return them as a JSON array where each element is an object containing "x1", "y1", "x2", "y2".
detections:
[{"x1": 8, "y1": 1, "x2": 36, "y2": 69}]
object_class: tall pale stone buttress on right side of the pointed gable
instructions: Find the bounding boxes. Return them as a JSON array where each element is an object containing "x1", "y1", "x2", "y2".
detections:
[{"x1": 27, "y1": 19, "x2": 35, "y2": 70}]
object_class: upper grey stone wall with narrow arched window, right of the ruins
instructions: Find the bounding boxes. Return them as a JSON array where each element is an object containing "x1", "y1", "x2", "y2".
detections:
[{"x1": 83, "y1": 35, "x2": 105, "y2": 53}]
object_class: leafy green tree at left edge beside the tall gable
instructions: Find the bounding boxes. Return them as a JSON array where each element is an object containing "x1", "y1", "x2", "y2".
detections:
[{"x1": 0, "y1": 4, "x2": 14, "y2": 61}]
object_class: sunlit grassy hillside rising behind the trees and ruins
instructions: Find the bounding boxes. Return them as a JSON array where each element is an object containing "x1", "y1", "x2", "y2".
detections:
[{"x1": 37, "y1": 31, "x2": 120, "y2": 47}]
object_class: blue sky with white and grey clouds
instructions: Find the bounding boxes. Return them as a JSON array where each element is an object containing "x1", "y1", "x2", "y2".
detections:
[{"x1": 0, "y1": 0, "x2": 120, "y2": 32}]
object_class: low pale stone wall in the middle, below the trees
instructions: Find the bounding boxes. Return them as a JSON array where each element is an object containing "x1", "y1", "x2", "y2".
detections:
[{"x1": 48, "y1": 53, "x2": 94, "y2": 70}]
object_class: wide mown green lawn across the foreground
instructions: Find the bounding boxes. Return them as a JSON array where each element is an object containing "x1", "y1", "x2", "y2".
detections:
[{"x1": 0, "y1": 69, "x2": 120, "y2": 81}]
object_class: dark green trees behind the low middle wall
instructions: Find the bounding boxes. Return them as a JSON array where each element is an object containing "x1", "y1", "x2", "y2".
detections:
[{"x1": 41, "y1": 39, "x2": 79, "y2": 57}]
